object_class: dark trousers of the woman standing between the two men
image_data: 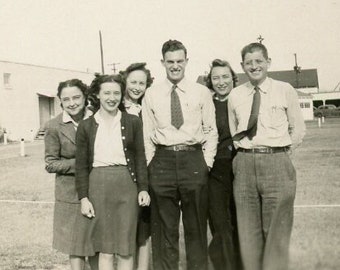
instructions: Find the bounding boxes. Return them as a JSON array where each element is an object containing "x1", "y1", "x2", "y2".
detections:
[{"x1": 208, "y1": 158, "x2": 241, "y2": 270}]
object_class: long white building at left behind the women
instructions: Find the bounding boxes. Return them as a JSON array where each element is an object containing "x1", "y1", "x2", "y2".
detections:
[{"x1": 0, "y1": 61, "x2": 93, "y2": 140}]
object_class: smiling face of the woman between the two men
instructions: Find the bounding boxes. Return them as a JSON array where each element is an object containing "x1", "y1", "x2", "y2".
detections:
[{"x1": 210, "y1": 67, "x2": 233, "y2": 98}]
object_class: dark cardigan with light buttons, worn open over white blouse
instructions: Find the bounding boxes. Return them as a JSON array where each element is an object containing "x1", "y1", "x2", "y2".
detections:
[{"x1": 76, "y1": 112, "x2": 148, "y2": 199}]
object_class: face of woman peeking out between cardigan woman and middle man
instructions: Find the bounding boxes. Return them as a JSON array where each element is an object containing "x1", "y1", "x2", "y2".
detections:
[{"x1": 126, "y1": 70, "x2": 147, "y2": 102}]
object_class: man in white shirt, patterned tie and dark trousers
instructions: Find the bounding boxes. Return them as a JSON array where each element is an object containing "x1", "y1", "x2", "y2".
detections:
[{"x1": 142, "y1": 40, "x2": 218, "y2": 270}]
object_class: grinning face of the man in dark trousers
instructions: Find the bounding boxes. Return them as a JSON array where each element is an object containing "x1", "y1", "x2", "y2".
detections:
[{"x1": 162, "y1": 50, "x2": 188, "y2": 84}]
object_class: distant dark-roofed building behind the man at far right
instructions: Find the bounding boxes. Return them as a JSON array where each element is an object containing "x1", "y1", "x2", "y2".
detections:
[{"x1": 197, "y1": 69, "x2": 319, "y2": 120}]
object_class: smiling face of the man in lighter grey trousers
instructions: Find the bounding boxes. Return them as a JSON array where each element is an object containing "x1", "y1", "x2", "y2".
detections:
[{"x1": 242, "y1": 50, "x2": 270, "y2": 86}]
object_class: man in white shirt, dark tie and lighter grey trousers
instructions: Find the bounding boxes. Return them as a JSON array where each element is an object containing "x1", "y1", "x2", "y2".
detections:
[{"x1": 228, "y1": 43, "x2": 305, "y2": 270}]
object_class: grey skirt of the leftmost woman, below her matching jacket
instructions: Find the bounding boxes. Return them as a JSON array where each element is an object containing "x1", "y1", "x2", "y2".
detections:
[{"x1": 52, "y1": 201, "x2": 93, "y2": 256}]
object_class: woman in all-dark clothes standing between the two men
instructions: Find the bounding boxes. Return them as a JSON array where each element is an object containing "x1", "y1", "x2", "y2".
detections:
[{"x1": 207, "y1": 59, "x2": 241, "y2": 270}]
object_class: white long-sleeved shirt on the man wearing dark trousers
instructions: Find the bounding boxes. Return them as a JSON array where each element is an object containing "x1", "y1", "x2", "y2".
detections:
[{"x1": 142, "y1": 78, "x2": 218, "y2": 167}]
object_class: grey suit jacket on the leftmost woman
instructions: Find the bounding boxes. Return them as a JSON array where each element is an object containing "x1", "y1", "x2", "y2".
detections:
[{"x1": 45, "y1": 113, "x2": 79, "y2": 203}]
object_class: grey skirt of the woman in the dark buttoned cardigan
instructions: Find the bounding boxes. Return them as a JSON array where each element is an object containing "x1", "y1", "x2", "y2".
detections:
[{"x1": 89, "y1": 166, "x2": 138, "y2": 256}]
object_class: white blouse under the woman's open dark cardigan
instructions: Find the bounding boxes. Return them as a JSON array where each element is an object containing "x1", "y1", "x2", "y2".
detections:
[{"x1": 93, "y1": 110, "x2": 127, "y2": 167}]
